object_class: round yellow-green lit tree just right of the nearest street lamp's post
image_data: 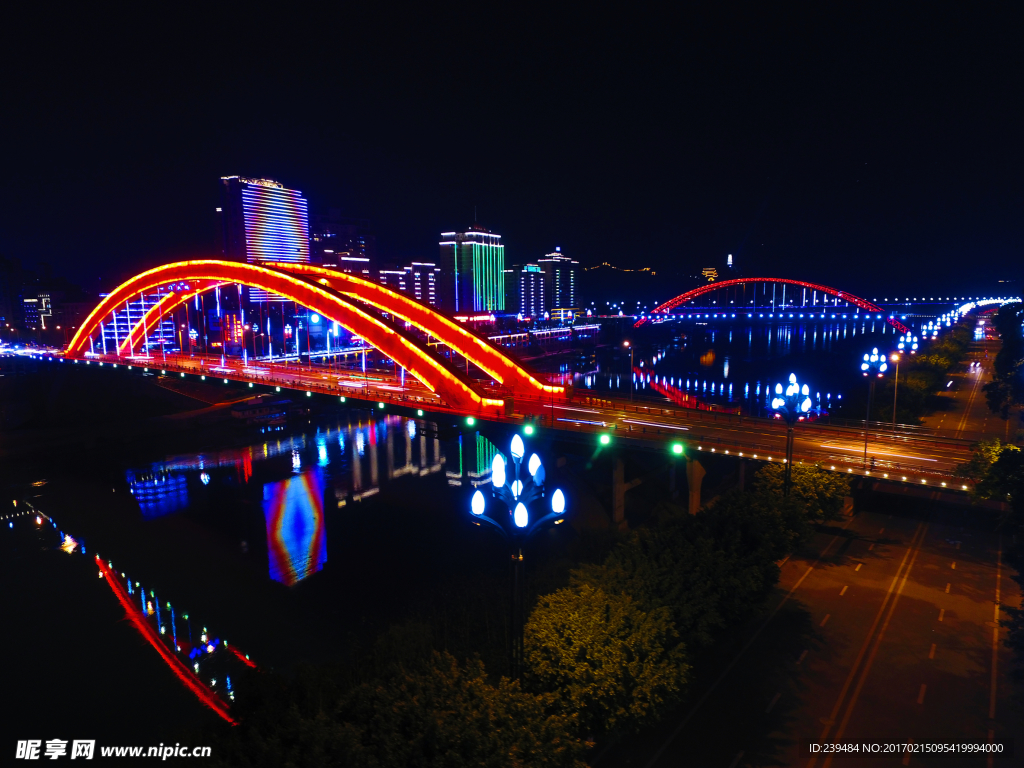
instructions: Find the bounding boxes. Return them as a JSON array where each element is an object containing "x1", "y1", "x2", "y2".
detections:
[{"x1": 525, "y1": 584, "x2": 689, "y2": 731}]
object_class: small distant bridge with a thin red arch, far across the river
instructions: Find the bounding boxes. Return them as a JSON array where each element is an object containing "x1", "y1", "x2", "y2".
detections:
[{"x1": 635, "y1": 278, "x2": 910, "y2": 334}]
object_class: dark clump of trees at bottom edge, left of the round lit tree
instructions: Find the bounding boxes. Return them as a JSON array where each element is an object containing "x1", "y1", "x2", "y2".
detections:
[{"x1": 214, "y1": 653, "x2": 587, "y2": 768}]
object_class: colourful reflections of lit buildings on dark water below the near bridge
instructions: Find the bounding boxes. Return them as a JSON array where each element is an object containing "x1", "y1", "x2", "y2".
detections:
[{"x1": 126, "y1": 413, "x2": 446, "y2": 586}]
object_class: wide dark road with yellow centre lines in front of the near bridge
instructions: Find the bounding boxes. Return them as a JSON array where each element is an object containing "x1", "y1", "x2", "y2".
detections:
[{"x1": 599, "y1": 499, "x2": 1024, "y2": 768}]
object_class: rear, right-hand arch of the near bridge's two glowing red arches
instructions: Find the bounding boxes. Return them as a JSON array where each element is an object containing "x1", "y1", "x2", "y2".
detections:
[{"x1": 266, "y1": 262, "x2": 565, "y2": 395}]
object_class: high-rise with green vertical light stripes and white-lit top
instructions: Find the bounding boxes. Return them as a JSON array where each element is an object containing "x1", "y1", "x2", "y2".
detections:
[{"x1": 439, "y1": 224, "x2": 505, "y2": 312}]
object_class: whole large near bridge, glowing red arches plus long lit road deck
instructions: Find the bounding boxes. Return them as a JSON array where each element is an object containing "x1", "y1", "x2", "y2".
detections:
[{"x1": 43, "y1": 259, "x2": 976, "y2": 506}]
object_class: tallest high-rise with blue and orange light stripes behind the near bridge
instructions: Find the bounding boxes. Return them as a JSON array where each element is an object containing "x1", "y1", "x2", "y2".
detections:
[{"x1": 217, "y1": 176, "x2": 309, "y2": 301}]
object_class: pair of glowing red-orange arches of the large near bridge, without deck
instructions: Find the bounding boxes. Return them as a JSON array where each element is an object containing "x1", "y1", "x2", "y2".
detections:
[{"x1": 65, "y1": 259, "x2": 565, "y2": 415}]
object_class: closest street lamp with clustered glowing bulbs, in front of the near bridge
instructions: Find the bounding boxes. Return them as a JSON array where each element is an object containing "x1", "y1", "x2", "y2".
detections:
[{"x1": 470, "y1": 435, "x2": 565, "y2": 680}]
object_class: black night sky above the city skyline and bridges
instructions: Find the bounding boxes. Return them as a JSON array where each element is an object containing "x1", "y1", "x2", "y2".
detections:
[{"x1": 0, "y1": 2, "x2": 1024, "y2": 300}]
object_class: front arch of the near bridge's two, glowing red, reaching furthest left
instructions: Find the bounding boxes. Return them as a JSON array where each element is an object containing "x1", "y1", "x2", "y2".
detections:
[{"x1": 66, "y1": 259, "x2": 504, "y2": 412}]
